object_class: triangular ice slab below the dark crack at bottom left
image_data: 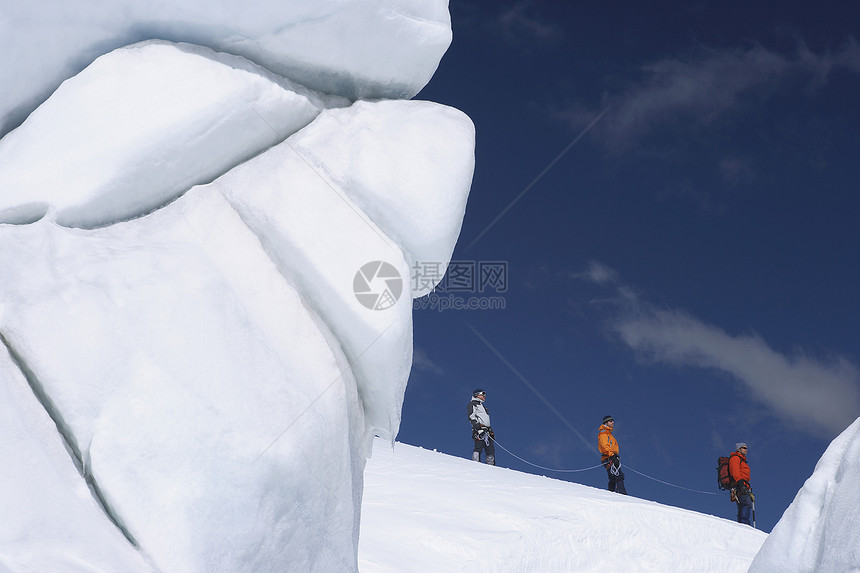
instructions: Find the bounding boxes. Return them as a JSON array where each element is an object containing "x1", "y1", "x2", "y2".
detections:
[{"x1": 0, "y1": 347, "x2": 151, "y2": 573}]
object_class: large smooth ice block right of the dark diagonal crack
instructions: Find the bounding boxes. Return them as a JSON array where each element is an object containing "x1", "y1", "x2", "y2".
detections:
[{"x1": 0, "y1": 192, "x2": 366, "y2": 571}]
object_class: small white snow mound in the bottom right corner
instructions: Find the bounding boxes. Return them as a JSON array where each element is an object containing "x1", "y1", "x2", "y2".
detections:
[{"x1": 750, "y1": 418, "x2": 860, "y2": 573}]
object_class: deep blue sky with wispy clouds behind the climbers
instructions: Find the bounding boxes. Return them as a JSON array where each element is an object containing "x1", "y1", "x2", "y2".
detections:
[{"x1": 398, "y1": 0, "x2": 860, "y2": 530}]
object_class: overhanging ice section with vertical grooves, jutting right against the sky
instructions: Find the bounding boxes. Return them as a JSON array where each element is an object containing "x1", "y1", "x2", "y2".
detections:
[{"x1": 210, "y1": 101, "x2": 474, "y2": 438}]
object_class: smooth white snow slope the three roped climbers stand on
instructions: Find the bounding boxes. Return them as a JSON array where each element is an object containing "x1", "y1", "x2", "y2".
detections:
[{"x1": 359, "y1": 440, "x2": 766, "y2": 573}]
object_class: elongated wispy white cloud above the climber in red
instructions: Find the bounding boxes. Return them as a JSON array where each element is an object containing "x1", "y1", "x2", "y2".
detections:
[{"x1": 579, "y1": 262, "x2": 860, "y2": 436}]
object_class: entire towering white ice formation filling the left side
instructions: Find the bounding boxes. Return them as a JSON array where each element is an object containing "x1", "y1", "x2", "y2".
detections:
[{"x1": 0, "y1": 0, "x2": 474, "y2": 572}]
